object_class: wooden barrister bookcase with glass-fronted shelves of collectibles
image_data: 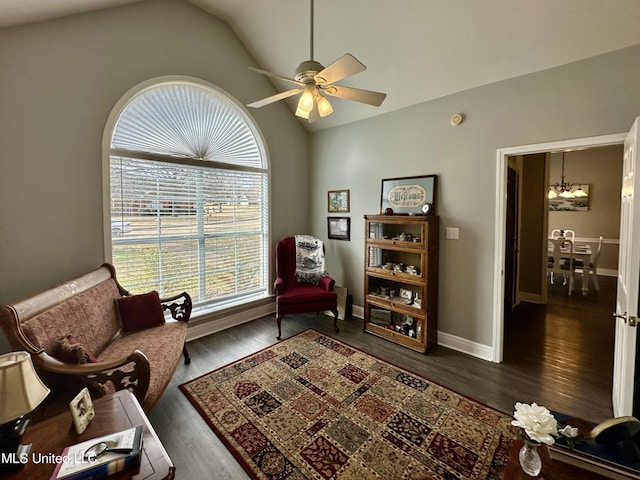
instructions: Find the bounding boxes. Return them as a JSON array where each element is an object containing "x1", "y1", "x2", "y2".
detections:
[{"x1": 364, "y1": 215, "x2": 439, "y2": 353}]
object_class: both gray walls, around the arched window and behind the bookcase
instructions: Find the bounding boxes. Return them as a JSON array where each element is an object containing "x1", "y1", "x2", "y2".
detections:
[{"x1": 0, "y1": 0, "x2": 640, "y2": 354}]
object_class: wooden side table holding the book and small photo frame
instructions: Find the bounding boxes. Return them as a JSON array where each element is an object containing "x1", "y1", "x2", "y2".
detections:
[{"x1": 0, "y1": 390, "x2": 175, "y2": 480}]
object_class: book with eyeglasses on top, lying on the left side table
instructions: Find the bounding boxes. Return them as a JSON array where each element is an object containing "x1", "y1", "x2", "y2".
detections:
[{"x1": 50, "y1": 425, "x2": 142, "y2": 480}]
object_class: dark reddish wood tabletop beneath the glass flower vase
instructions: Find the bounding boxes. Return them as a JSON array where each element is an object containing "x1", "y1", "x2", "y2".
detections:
[{"x1": 504, "y1": 440, "x2": 606, "y2": 480}]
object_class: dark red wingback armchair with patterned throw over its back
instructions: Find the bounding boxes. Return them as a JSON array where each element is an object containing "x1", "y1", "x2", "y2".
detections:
[{"x1": 274, "y1": 235, "x2": 338, "y2": 340}]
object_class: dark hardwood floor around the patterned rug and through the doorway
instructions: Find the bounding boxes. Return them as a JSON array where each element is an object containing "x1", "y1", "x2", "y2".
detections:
[{"x1": 149, "y1": 277, "x2": 615, "y2": 480}]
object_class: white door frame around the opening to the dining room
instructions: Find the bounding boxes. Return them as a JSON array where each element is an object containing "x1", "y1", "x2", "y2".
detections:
[{"x1": 491, "y1": 132, "x2": 627, "y2": 363}]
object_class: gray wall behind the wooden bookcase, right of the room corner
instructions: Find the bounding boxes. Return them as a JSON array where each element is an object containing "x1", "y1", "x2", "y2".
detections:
[{"x1": 311, "y1": 46, "x2": 640, "y2": 345}]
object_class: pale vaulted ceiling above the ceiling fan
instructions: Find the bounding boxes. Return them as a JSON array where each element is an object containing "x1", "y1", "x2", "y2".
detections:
[{"x1": 0, "y1": 0, "x2": 640, "y2": 131}]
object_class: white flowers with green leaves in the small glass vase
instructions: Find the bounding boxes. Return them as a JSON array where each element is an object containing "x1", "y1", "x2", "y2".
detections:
[{"x1": 511, "y1": 402, "x2": 580, "y2": 450}]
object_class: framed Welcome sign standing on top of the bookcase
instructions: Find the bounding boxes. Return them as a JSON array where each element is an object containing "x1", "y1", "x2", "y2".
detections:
[{"x1": 380, "y1": 175, "x2": 437, "y2": 215}]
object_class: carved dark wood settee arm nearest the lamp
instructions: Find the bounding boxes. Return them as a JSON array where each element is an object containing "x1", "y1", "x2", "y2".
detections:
[{"x1": 32, "y1": 350, "x2": 151, "y2": 403}]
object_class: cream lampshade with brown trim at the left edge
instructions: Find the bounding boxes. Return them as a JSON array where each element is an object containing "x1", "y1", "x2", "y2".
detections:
[{"x1": 0, "y1": 352, "x2": 50, "y2": 424}]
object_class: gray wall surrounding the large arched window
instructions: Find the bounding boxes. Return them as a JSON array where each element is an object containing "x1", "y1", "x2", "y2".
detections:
[{"x1": 0, "y1": 0, "x2": 309, "y2": 351}]
